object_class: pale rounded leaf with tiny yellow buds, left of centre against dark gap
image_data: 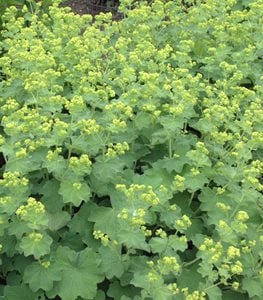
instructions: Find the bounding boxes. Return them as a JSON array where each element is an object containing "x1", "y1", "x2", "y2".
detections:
[{"x1": 59, "y1": 180, "x2": 91, "y2": 206}]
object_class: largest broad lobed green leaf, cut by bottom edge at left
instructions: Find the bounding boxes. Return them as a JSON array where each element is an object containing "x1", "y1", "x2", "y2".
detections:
[{"x1": 51, "y1": 246, "x2": 104, "y2": 300}]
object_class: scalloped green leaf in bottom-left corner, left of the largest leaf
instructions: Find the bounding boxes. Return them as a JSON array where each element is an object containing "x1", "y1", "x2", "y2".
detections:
[{"x1": 23, "y1": 262, "x2": 62, "y2": 292}]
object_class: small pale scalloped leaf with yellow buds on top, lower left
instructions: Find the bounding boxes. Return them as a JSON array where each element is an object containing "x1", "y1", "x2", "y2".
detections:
[{"x1": 19, "y1": 232, "x2": 52, "y2": 259}]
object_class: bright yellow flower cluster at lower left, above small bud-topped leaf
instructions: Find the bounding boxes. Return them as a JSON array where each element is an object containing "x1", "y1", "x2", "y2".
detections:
[{"x1": 16, "y1": 197, "x2": 45, "y2": 220}]
